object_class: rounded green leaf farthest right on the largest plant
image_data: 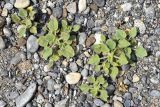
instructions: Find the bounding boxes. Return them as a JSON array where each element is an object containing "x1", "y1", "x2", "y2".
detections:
[{"x1": 136, "y1": 46, "x2": 147, "y2": 58}]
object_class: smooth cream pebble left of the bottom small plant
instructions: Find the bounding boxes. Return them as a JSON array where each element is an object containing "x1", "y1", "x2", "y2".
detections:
[{"x1": 66, "y1": 72, "x2": 81, "y2": 84}]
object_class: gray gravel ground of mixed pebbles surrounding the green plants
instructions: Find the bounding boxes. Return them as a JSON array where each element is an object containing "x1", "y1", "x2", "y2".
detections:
[{"x1": 0, "y1": 0, "x2": 160, "y2": 107}]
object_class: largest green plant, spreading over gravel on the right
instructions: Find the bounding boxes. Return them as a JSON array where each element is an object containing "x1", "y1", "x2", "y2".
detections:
[{"x1": 88, "y1": 27, "x2": 147, "y2": 80}]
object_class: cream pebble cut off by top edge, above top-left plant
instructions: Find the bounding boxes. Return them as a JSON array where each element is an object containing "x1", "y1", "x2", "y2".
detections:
[{"x1": 14, "y1": 0, "x2": 30, "y2": 8}]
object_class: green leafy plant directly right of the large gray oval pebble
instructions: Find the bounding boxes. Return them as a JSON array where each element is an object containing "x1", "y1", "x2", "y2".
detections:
[{"x1": 38, "y1": 17, "x2": 80, "y2": 64}]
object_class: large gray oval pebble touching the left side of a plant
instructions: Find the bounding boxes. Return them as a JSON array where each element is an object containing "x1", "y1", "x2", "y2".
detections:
[{"x1": 27, "y1": 35, "x2": 39, "y2": 53}]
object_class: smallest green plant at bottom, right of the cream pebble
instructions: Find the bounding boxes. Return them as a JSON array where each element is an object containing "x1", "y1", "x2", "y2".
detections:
[{"x1": 80, "y1": 75, "x2": 108, "y2": 101}]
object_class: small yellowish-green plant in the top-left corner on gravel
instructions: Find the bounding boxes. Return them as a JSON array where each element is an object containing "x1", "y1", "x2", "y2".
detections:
[{"x1": 11, "y1": 7, "x2": 37, "y2": 37}]
